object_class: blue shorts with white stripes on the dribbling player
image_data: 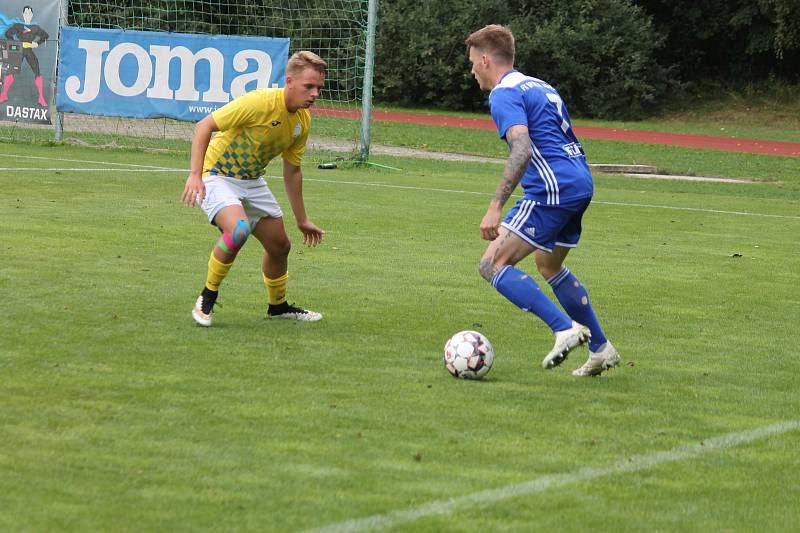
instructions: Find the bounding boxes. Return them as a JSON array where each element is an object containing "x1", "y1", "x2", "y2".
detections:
[{"x1": 500, "y1": 197, "x2": 592, "y2": 252}]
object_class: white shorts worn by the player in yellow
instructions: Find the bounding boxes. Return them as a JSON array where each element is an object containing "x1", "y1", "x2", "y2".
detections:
[{"x1": 200, "y1": 176, "x2": 283, "y2": 229}]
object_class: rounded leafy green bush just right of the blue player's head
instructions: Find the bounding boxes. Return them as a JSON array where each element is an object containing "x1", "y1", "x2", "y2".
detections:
[{"x1": 512, "y1": 0, "x2": 669, "y2": 118}]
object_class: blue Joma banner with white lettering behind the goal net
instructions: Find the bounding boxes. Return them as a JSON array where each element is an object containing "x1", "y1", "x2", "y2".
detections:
[{"x1": 56, "y1": 27, "x2": 289, "y2": 121}]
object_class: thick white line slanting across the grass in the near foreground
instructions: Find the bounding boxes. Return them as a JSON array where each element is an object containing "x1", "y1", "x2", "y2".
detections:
[{"x1": 306, "y1": 420, "x2": 800, "y2": 533}]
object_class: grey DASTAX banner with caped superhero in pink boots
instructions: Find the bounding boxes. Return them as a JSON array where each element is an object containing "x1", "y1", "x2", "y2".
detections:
[{"x1": 0, "y1": 0, "x2": 59, "y2": 124}]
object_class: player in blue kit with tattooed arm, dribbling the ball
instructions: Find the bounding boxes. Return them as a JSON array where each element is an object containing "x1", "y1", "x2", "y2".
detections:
[{"x1": 466, "y1": 24, "x2": 620, "y2": 376}]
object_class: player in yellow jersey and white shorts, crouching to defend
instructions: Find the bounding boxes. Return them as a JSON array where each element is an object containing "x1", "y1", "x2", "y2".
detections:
[{"x1": 181, "y1": 52, "x2": 326, "y2": 326}]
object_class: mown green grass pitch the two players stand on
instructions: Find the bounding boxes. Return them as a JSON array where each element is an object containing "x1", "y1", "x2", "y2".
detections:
[{"x1": 0, "y1": 139, "x2": 800, "y2": 532}]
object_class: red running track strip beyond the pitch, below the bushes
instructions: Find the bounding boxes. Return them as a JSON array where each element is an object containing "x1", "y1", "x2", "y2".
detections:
[{"x1": 319, "y1": 109, "x2": 800, "y2": 157}]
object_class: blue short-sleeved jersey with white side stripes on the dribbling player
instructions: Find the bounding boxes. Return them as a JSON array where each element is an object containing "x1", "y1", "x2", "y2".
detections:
[{"x1": 489, "y1": 70, "x2": 594, "y2": 205}]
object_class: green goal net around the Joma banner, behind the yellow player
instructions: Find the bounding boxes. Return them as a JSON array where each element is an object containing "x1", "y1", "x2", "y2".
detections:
[{"x1": 0, "y1": 0, "x2": 368, "y2": 160}]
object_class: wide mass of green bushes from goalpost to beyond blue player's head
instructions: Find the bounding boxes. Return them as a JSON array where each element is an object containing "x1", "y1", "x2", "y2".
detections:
[{"x1": 375, "y1": 0, "x2": 667, "y2": 118}]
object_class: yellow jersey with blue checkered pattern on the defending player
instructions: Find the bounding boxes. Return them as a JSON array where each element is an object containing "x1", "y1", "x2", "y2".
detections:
[{"x1": 203, "y1": 89, "x2": 311, "y2": 180}]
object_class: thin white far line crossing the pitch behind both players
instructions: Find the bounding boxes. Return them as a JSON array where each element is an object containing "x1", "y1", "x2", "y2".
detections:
[{"x1": 0, "y1": 153, "x2": 800, "y2": 220}]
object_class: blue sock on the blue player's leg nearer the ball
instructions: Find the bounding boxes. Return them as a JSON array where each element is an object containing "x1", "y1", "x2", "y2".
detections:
[{"x1": 492, "y1": 265, "x2": 572, "y2": 331}]
